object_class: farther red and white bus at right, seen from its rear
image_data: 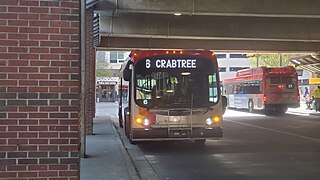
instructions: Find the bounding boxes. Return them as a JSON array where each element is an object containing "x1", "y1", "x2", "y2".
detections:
[{"x1": 222, "y1": 66, "x2": 300, "y2": 114}]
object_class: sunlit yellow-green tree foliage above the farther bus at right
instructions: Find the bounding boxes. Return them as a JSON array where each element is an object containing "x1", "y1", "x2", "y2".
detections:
[{"x1": 247, "y1": 54, "x2": 297, "y2": 67}]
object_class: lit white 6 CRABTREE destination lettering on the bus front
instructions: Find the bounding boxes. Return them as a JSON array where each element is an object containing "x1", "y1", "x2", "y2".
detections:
[{"x1": 145, "y1": 58, "x2": 197, "y2": 69}]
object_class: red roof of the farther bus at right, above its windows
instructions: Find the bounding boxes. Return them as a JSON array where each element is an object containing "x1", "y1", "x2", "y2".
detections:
[{"x1": 223, "y1": 66, "x2": 297, "y2": 83}]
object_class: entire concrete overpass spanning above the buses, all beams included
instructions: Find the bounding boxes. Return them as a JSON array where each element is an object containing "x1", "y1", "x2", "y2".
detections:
[{"x1": 94, "y1": 0, "x2": 320, "y2": 52}]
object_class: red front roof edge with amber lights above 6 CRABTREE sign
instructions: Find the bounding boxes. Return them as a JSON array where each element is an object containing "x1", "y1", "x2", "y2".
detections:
[{"x1": 129, "y1": 50, "x2": 216, "y2": 63}]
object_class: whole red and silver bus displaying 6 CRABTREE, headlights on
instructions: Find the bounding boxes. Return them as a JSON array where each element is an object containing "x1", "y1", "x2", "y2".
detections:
[{"x1": 119, "y1": 50, "x2": 226, "y2": 143}]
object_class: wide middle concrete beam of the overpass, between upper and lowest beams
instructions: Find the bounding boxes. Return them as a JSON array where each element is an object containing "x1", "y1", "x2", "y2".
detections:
[{"x1": 100, "y1": 14, "x2": 320, "y2": 42}]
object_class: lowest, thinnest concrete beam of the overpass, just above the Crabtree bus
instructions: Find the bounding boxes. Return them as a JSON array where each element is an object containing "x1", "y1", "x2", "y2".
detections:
[{"x1": 97, "y1": 36, "x2": 320, "y2": 53}]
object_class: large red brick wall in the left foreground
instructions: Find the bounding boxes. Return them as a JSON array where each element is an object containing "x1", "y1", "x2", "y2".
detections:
[{"x1": 0, "y1": 0, "x2": 80, "y2": 179}]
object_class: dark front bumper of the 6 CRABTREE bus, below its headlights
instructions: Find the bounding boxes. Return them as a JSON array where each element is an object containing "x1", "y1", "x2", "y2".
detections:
[{"x1": 132, "y1": 127, "x2": 223, "y2": 141}]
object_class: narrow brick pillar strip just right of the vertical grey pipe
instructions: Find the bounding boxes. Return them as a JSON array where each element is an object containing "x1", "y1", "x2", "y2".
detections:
[{"x1": 85, "y1": 7, "x2": 96, "y2": 134}]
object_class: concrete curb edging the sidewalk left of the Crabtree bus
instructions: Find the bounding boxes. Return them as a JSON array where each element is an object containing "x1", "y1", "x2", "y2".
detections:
[{"x1": 112, "y1": 123, "x2": 141, "y2": 180}]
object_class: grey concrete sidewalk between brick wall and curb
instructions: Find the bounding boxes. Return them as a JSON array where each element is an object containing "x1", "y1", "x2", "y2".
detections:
[{"x1": 80, "y1": 104, "x2": 140, "y2": 180}]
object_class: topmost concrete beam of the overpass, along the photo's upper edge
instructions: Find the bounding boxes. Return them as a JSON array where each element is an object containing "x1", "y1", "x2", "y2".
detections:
[{"x1": 95, "y1": 0, "x2": 320, "y2": 18}]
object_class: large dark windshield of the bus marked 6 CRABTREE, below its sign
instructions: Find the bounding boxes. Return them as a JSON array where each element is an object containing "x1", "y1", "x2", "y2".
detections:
[{"x1": 135, "y1": 57, "x2": 219, "y2": 108}]
